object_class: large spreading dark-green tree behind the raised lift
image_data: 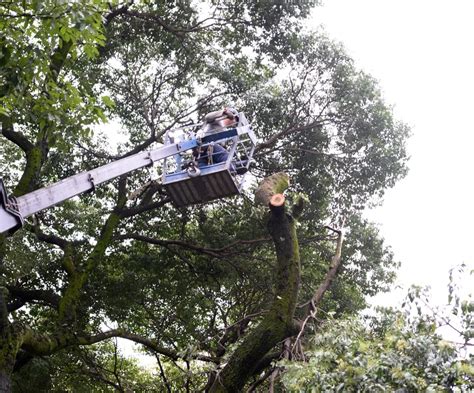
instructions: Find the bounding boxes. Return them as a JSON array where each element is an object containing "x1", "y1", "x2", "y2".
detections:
[{"x1": 0, "y1": 0, "x2": 408, "y2": 391}]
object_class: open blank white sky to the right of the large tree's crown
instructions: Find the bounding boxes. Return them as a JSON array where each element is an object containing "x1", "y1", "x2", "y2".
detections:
[{"x1": 313, "y1": 0, "x2": 474, "y2": 302}]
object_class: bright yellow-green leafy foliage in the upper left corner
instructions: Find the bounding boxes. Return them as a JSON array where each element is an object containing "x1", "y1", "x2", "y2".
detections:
[{"x1": 0, "y1": 1, "x2": 105, "y2": 149}]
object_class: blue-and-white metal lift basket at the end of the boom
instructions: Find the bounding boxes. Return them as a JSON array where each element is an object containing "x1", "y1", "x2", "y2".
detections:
[{"x1": 162, "y1": 113, "x2": 256, "y2": 207}]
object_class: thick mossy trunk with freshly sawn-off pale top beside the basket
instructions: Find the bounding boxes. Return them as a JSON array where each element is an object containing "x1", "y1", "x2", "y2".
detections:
[{"x1": 210, "y1": 174, "x2": 300, "y2": 392}]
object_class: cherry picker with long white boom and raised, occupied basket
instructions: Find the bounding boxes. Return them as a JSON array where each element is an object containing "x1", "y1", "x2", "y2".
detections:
[{"x1": 0, "y1": 108, "x2": 257, "y2": 234}]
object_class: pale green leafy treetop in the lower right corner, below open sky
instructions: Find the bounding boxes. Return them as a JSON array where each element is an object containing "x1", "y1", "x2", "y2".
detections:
[{"x1": 282, "y1": 264, "x2": 474, "y2": 392}]
